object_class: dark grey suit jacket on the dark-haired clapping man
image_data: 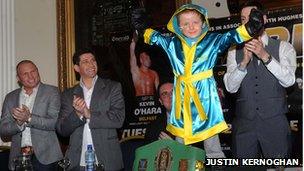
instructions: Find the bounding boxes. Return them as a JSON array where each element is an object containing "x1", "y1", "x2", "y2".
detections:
[{"x1": 56, "y1": 78, "x2": 125, "y2": 170}]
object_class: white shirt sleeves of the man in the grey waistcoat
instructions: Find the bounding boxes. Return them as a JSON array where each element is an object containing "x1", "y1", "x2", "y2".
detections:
[{"x1": 224, "y1": 32, "x2": 297, "y2": 93}]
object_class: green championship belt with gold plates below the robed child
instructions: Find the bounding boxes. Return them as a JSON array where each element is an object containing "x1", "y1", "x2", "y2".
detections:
[{"x1": 133, "y1": 139, "x2": 205, "y2": 171}]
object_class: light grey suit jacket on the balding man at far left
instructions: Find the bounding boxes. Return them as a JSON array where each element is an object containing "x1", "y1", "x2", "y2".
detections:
[{"x1": 0, "y1": 83, "x2": 62, "y2": 170}]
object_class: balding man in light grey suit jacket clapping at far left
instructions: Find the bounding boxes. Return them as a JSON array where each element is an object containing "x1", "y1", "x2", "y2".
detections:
[{"x1": 0, "y1": 60, "x2": 62, "y2": 171}]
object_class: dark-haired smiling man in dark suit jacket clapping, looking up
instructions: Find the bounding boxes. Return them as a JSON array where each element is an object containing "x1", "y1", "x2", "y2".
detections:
[{"x1": 56, "y1": 49, "x2": 125, "y2": 171}]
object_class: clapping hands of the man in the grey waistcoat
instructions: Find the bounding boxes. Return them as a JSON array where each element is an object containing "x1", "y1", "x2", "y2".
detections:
[{"x1": 244, "y1": 37, "x2": 269, "y2": 62}]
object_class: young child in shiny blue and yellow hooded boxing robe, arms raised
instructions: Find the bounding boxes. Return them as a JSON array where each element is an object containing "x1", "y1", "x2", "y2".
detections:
[{"x1": 133, "y1": 4, "x2": 263, "y2": 144}]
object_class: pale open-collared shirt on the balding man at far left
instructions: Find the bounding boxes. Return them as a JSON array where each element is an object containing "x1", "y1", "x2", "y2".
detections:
[{"x1": 19, "y1": 85, "x2": 39, "y2": 147}]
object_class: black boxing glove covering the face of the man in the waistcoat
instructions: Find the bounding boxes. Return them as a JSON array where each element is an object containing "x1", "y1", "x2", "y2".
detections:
[{"x1": 245, "y1": 8, "x2": 264, "y2": 37}]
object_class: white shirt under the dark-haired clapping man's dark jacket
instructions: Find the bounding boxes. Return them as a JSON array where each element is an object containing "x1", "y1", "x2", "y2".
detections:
[{"x1": 80, "y1": 76, "x2": 98, "y2": 166}]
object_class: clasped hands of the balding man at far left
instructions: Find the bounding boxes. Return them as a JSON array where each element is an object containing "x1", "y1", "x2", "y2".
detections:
[{"x1": 12, "y1": 105, "x2": 31, "y2": 125}]
